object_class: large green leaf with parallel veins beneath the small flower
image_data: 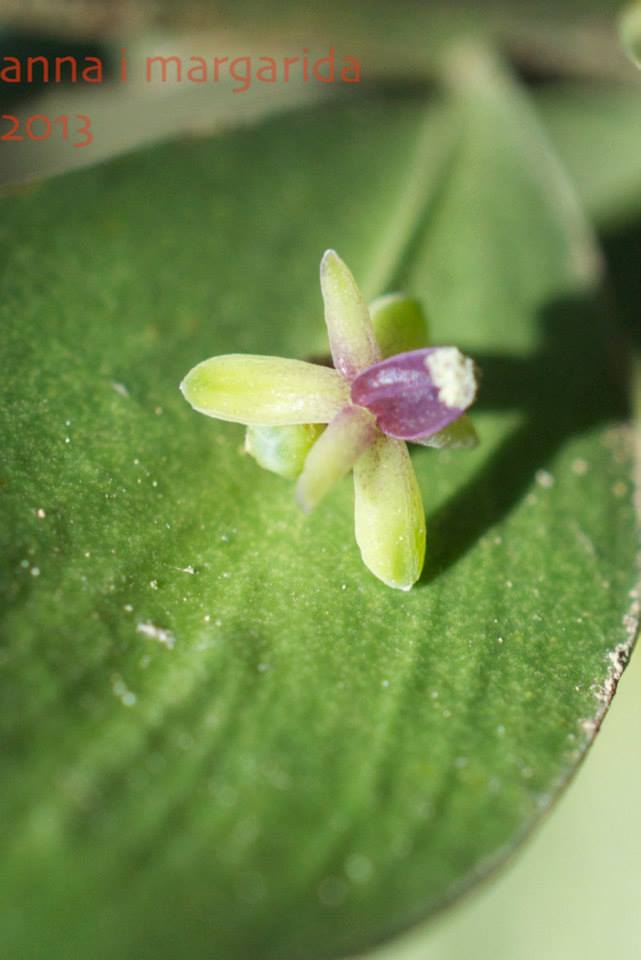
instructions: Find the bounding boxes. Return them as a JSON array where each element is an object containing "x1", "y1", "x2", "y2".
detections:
[{"x1": 0, "y1": 50, "x2": 638, "y2": 960}]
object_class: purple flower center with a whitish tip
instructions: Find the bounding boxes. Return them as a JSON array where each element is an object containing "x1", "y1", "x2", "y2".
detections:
[{"x1": 351, "y1": 347, "x2": 477, "y2": 440}]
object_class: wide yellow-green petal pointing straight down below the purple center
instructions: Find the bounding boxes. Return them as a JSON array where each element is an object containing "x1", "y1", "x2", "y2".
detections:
[{"x1": 354, "y1": 434, "x2": 425, "y2": 590}]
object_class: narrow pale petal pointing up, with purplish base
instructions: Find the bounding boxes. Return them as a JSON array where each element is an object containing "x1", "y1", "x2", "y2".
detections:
[{"x1": 321, "y1": 250, "x2": 381, "y2": 380}]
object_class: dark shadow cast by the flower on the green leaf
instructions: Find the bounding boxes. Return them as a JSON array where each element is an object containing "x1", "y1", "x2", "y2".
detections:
[{"x1": 419, "y1": 282, "x2": 627, "y2": 585}]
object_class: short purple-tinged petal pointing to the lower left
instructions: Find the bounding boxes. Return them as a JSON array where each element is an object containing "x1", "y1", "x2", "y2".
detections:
[{"x1": 296, "y1": 406, "x2": 377, "y2": 511}]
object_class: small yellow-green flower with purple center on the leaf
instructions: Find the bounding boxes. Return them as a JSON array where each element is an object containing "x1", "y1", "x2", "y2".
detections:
[{"x1": 180, "y1": 250, "x2": 477, "y2": 590}]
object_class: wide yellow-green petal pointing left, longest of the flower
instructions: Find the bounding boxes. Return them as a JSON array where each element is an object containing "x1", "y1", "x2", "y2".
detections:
[{"x1": 180, "y1": 353, "x2": 349, "y2": 426}]
